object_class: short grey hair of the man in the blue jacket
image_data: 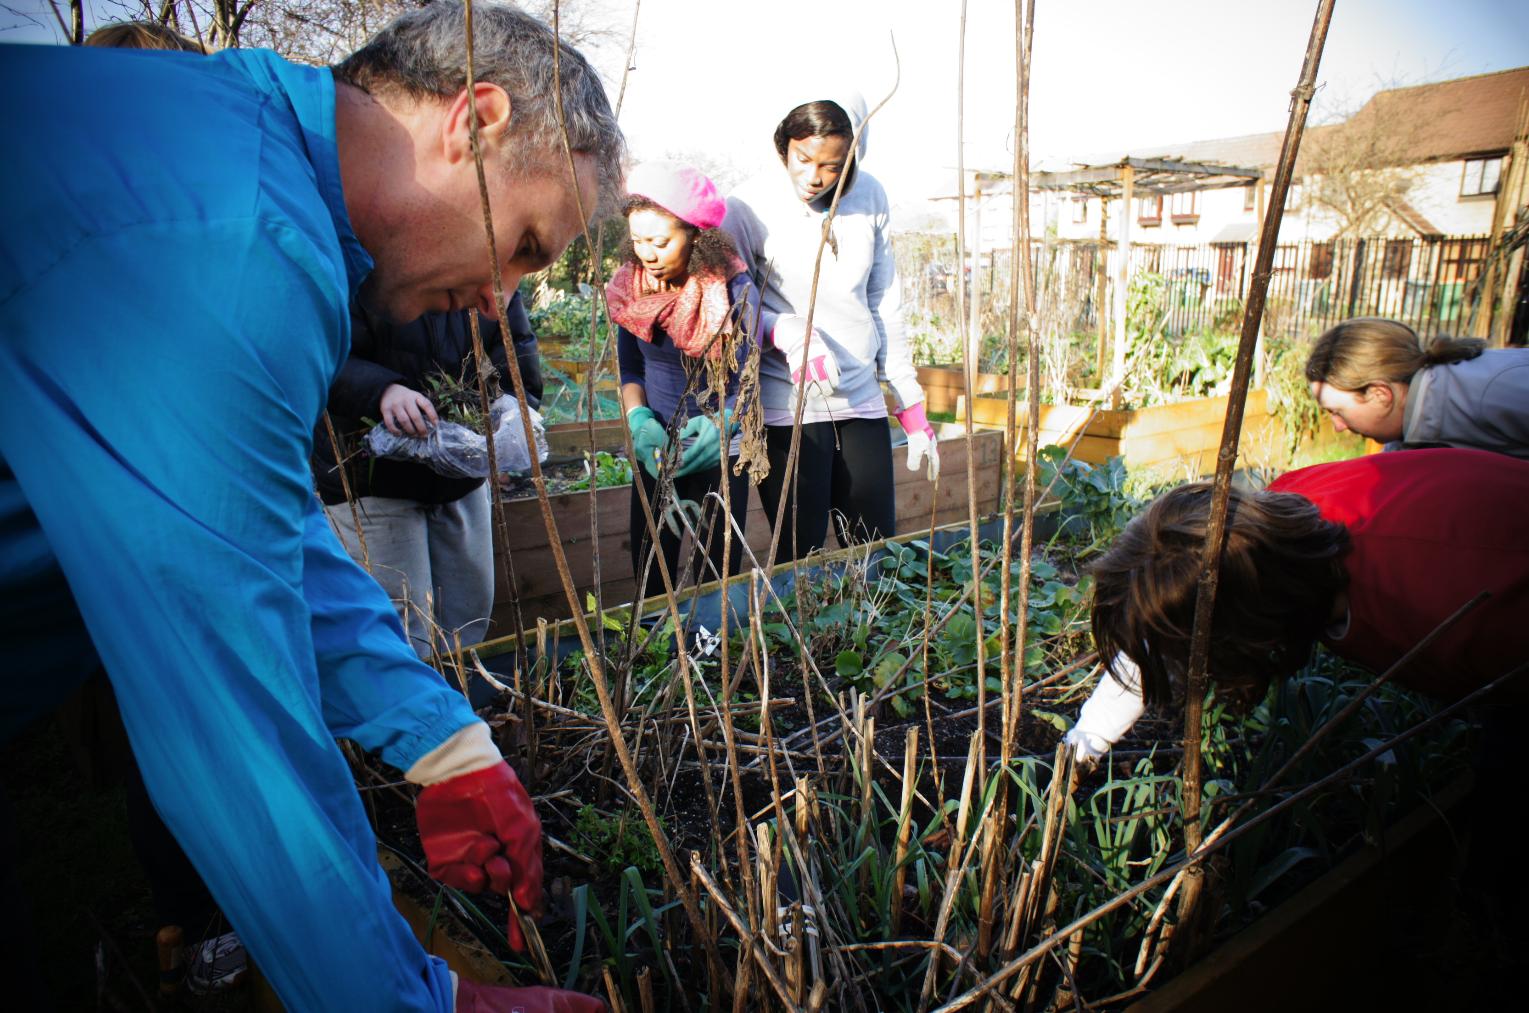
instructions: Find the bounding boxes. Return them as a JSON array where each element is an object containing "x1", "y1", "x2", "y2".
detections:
[{"x1": 335, "y1": 0, "x2": 625, "y2": 214}]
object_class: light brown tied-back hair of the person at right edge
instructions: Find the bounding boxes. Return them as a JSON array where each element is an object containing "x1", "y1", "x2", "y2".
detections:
[{"x1": 1306, "y1": 316, "x2": 1486, "y2": 391}]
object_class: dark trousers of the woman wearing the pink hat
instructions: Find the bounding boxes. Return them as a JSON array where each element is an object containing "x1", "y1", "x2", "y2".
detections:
[{"x1": 631, "y1": 457, "x2": 749, "y2": 597}]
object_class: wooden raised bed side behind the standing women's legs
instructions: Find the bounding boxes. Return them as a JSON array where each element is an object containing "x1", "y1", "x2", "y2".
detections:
[{"x1": 489, "y1": 422, "x2": 1003, "y2": 637}]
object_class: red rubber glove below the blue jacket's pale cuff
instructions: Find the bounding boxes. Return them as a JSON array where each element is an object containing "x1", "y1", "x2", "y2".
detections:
[{"x1": 414, "y1": 762, "x2": 552, "y2": 953}]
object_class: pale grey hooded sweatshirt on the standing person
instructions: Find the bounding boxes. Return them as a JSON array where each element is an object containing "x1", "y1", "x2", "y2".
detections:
[{"x1": 722, "y1": 89, "x2": 924, "y2": 422}]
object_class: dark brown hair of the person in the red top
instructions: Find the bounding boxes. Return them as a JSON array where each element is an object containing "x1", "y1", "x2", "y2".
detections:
[{"x1": 1089, "y1": 481, "x2": 1349, "y2": 706}]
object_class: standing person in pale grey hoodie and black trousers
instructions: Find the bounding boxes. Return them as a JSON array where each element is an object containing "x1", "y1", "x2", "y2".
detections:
[{"x1": 723, "y1": 89, "x2": 939, "y2": 562}]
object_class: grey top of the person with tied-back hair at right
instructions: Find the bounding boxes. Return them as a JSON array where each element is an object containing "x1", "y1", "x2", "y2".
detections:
[{"x1": 1393, "y1": 348, "x2": 1529, "y2": 460}]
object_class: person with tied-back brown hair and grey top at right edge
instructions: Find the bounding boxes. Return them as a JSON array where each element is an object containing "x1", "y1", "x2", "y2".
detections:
[{"x1": 1306, "y1": 316, "x2": 1529, "y2": 460}]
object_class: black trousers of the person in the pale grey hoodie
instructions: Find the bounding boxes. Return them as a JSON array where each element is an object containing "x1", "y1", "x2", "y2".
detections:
[{"x1": 760, "y1": 419, "x2": 898, "y2": 562}]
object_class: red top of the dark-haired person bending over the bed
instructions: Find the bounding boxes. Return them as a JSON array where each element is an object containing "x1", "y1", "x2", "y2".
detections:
[{"x1": 1269, "y1": 449, "x2": 1529, "y2": 703}]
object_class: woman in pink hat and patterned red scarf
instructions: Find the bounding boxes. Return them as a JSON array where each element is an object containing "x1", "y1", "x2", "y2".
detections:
[{"x1": 605, "y1": 162, "x2": 758, "y2": 597}]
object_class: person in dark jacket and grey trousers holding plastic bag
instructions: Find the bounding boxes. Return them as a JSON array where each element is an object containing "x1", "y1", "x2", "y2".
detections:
[{"x1": 313, "y1": 292, "x2": 543, "y2": 657}]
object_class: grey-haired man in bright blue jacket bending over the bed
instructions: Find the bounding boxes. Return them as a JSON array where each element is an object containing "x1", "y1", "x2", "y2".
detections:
[{"x1": 0, "y1": 3, "x2": 622, "y2": 1011}]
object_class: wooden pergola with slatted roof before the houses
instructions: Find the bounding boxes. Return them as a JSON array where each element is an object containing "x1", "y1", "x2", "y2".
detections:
[{"x1": 1031, "y1": 157, "x2": 1263, "y2": 399}]
